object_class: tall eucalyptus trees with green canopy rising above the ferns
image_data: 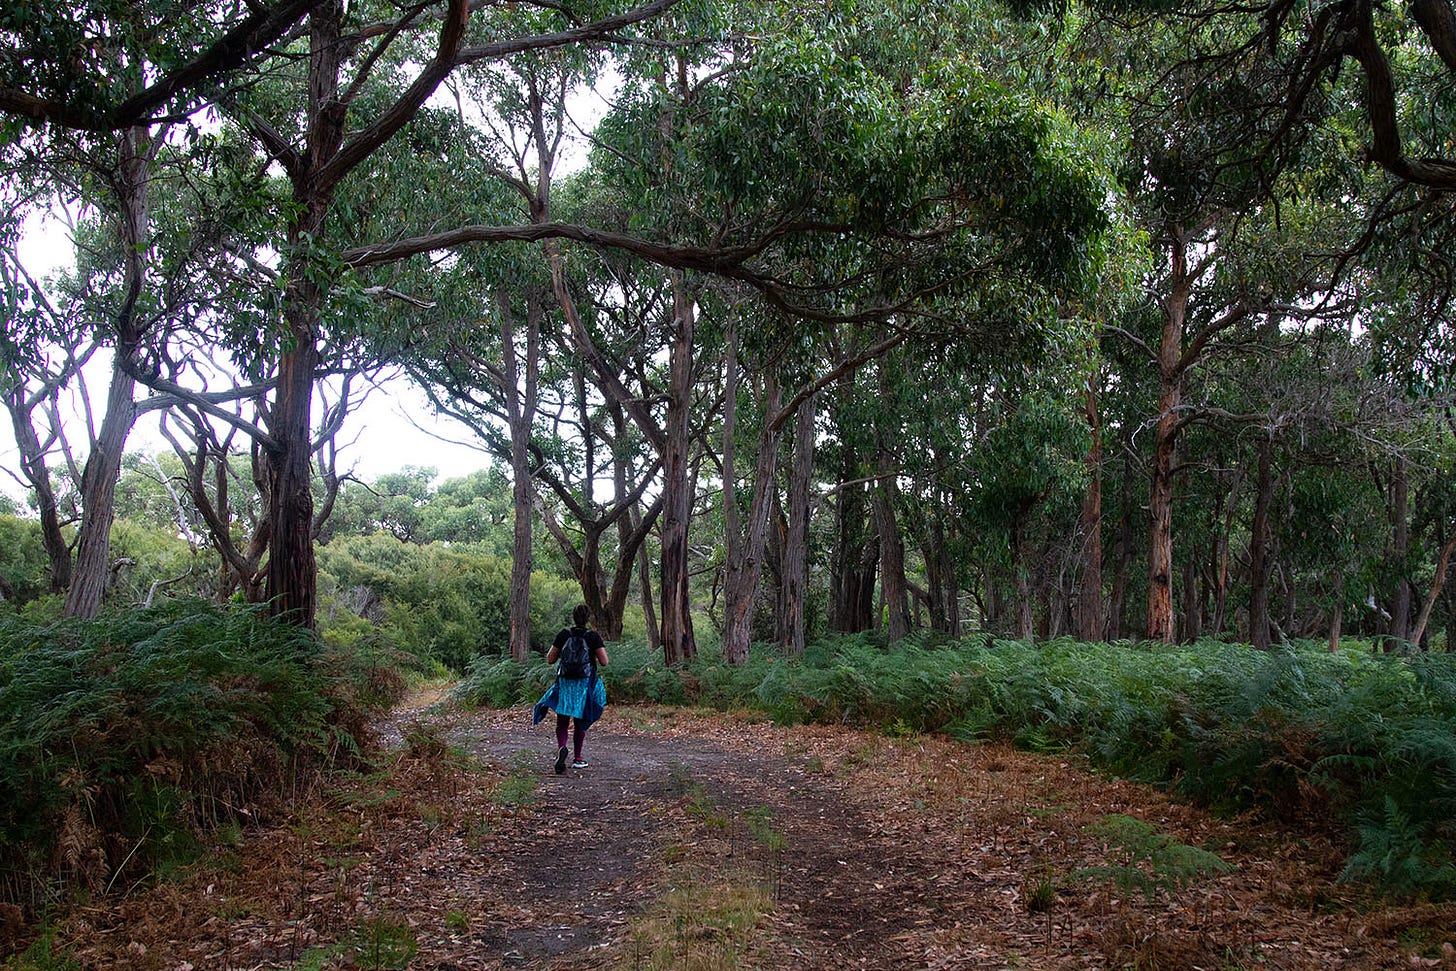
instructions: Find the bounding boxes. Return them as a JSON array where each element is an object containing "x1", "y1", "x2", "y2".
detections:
[{"x1": 0, "y1": 0, "x2": 1456, "y2": 662}]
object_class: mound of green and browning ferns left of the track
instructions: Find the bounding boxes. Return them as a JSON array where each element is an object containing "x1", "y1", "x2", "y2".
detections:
[{"x1": 0, "y1": 600, "x2": 402, "y2": 905}]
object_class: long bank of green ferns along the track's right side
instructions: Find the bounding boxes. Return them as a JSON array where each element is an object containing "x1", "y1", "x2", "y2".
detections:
[{"x1": 460, "y1": 635, "x2": 1456, "y2": 895}]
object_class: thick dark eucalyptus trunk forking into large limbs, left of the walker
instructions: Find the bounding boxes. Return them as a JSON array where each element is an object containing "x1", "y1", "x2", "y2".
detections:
[{"x1": 212, "y1": 0, "x2": 667, "y2": 625}]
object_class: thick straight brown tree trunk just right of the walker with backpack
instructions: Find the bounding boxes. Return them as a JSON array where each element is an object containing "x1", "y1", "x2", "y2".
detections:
[{"x1": 660, "y1": 272, "x2": 697, "y2": 664}]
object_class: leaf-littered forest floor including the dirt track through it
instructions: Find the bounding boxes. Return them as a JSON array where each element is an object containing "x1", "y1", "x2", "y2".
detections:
[{"x1": 39, "y1": 696, "x2": 1456, "y2": 971}]
